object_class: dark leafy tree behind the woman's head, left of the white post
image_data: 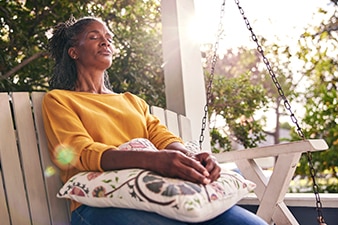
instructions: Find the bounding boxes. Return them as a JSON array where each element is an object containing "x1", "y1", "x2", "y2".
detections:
[{"x1": 0, "y1": 0, "x2": 165, "y2": 107}]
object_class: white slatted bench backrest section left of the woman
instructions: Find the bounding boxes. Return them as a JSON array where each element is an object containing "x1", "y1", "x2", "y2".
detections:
[{"x1": 0, "y1": 92, "x2": 69, "y2": 225}]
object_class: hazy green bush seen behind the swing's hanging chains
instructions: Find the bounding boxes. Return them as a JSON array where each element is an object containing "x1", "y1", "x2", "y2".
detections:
[{"x1": 203, "y1": 35, "x2": 299, "y2": 151}]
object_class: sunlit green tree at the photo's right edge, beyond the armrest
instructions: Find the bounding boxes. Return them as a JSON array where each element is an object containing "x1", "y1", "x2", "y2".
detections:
[{"x1": 293, "y1": 1, "x2": 338, "y2": 192}]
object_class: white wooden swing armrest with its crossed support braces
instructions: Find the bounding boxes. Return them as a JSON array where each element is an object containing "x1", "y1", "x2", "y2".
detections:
[{"x1": 222, "y1": 140, "x2": 328, "y2": 224}]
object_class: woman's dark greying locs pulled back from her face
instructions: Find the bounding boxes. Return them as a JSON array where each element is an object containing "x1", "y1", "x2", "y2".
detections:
[{"x1": 48, "y1": 16, "x2": 110, "y2": 91}]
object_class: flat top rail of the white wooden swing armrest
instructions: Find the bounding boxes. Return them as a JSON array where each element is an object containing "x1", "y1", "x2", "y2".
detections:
[{"x1": 214, "y1": 139, "x2": 328, "y2": 163}]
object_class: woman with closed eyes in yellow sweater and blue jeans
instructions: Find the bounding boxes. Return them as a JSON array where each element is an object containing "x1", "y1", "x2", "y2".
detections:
[{"x1": 43, "y1": 17, "x2": 266, "y2": 225}]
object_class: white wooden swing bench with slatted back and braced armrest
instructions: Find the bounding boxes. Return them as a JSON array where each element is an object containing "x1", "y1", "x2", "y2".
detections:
[{"x1": 0, "y1": 92, "x2": 328, "y2": 225}]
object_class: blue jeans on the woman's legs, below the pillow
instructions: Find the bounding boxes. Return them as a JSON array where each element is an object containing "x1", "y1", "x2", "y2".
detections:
[{"x1": 71, "y1": 205, "x2": 267, "y2": 225}]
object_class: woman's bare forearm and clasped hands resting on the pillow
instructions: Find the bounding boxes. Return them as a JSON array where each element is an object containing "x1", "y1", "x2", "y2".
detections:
[{"x1": 101, "y1": 142, "x2": 220, "y2": 184}]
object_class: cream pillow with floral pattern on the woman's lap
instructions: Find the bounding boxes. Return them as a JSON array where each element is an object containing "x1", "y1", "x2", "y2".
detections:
[{"x1": 57, "y1": 139, "x2": 256, "y2": 222}]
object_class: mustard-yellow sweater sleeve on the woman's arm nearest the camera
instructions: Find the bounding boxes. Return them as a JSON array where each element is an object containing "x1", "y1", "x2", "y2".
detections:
[{"x1": 42, "y1": 93, "x2": 116, "y2": 171}]
